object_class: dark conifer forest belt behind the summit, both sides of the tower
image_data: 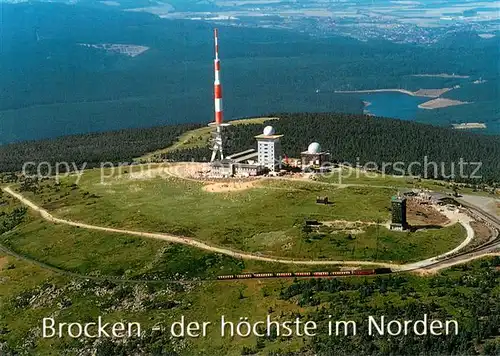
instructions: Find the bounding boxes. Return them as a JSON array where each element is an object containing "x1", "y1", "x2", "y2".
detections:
[{"x1": 0, "y1": 113, "x2": 500, "y2": 183}]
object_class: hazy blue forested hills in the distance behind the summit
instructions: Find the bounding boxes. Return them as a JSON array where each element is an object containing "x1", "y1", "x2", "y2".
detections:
[{"x1": 0, "y1": 3, "x2": 500, "y2": 144}]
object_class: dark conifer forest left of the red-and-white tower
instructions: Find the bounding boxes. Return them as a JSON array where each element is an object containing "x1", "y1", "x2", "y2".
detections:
[{"x1": 0, "y1": 124, "x2": 200, "y2": 172}]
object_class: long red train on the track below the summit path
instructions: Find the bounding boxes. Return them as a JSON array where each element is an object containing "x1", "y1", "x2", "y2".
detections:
[{"x1": 217, "y1": 268, "x2": 392, "y2": 280}]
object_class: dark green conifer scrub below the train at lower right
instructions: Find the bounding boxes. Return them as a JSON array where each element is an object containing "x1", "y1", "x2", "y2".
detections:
[{"x1": 274, "y1": 257, "x2": 500, "y2": 355}]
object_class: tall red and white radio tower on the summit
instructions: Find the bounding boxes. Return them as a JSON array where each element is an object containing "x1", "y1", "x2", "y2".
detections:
[{"x1": 208, "y1": 29, "x2": 229, "y2": 162}]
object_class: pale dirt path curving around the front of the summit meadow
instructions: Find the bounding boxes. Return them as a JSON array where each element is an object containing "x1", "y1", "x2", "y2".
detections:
[{"x1": 2, "y1": 187, "x2": 492, "y2": 271}]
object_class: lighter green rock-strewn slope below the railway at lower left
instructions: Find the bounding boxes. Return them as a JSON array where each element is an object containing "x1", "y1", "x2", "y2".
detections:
[{"x1": 0, "y1": 249, "x2": 308, "y2": 355}]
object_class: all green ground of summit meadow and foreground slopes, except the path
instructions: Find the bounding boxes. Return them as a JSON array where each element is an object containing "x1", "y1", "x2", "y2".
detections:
[{"x1": 0, "y1": 124, "x2": 500, "y2": 356}]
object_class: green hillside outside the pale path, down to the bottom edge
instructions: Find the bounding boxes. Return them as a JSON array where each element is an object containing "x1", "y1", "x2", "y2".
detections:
[{"x1": 0, "y1": 189, "x2": 500, "y2": 356}]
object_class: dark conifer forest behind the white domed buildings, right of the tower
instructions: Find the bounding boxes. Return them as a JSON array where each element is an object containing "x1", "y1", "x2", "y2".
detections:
[{"x1": 164, "y1": 113, "x2": 500, "y2": 183}]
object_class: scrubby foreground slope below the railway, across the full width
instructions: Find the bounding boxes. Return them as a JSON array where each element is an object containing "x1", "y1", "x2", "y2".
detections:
[{"x1": 0, "y1": 257, "x2": 500, "y2": 356}]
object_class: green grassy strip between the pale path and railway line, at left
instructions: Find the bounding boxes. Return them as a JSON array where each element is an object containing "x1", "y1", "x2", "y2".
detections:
[{"x1": 0, "y1": 189, "x2": 366, "y2": 281}]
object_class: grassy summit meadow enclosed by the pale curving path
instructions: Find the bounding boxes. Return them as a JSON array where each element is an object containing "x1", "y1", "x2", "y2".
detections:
[{"x1": 8, "y1": 166, "x2": 465, "y2": 262}]
